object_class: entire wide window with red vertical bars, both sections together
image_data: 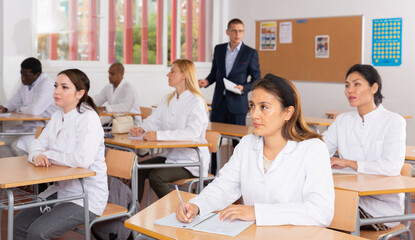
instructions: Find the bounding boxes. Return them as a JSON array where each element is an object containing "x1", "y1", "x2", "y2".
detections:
[{"x1": 37, "y1": 0, "x2": 212, "y2": 64}]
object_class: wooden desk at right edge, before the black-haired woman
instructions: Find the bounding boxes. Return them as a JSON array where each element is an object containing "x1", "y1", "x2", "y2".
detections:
[{"x1": 333, "y1": 173, "x2": 415, "y2": 235}]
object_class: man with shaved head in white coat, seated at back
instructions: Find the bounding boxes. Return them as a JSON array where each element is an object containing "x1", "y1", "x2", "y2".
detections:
[{"x1": 94, "y1": 63, "x2": 141, "y2": 124}]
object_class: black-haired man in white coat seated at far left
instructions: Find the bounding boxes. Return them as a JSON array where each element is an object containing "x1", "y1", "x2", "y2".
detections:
[{"x1": 0, "y1": 57, "x2": 57, "y2": 155}]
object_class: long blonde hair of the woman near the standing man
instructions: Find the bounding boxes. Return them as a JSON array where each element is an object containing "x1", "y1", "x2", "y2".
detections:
[{"x1": 167, "y1": 59, "x2": 208, "y2": 110}]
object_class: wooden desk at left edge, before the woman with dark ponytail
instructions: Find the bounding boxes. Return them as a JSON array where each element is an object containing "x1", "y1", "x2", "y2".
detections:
[{"x1": 0, "y1": 156, "x2": 95, "y2": 240}]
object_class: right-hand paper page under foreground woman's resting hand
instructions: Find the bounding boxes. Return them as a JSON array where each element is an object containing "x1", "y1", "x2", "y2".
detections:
[{"x1": 193, "y1": 213, "x2": 254, "y2": 237}]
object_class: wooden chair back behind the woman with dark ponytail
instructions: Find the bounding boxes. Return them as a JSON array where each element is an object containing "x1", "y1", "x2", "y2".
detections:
[{"x1": 105, "y1": 149, "x2": 135, "y2": 180}]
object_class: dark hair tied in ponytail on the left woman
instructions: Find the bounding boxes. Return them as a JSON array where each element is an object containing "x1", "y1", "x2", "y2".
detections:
[{"x1": 58, "y1": 69, "x2": 98, "y2": 113}]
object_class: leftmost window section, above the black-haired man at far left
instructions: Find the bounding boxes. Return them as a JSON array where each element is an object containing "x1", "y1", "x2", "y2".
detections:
[{"x1": 37, "y1": 0, "x2": 99, "y2": 61}]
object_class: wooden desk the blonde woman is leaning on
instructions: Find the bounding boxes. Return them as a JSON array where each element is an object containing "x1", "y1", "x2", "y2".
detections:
[{"x1": 105, "y1": 133, "x2": 210, "y2": 190}]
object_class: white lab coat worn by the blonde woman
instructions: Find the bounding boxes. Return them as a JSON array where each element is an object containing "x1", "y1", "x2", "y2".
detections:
[{"x1": 141, "y1": 90, "x2": 210, "y2": 177}]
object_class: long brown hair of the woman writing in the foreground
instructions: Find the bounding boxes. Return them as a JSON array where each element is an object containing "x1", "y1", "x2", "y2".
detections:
[{"x1": 252, "y1": 74, "x2": 323, "y2": 142}]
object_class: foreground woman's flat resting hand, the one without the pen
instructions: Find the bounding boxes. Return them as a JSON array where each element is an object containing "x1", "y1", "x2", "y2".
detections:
[{"x1": 219, "y1": 204, "x2": 255, "y2": 222}]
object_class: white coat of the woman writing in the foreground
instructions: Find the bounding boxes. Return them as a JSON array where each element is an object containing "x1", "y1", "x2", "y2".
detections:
[{"x1": 190, "y1": 135, "x2": 334, "y2": 226}]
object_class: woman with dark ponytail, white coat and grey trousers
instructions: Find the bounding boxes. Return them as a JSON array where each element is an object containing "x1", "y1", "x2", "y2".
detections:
[{"x1": 14, "y1": 69, "x2": 108, "y2": 239}]
